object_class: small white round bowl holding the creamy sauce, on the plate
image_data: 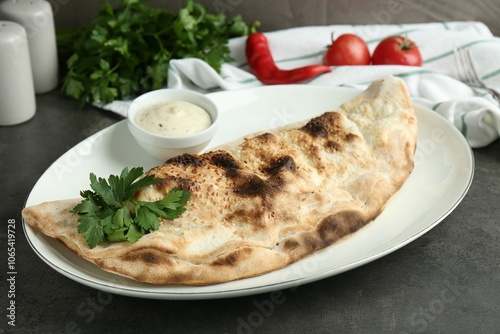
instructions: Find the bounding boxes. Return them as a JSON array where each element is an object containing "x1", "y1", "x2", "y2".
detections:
[{"x1": 127, "y1": 89, "x2": 219, "y2": 161}]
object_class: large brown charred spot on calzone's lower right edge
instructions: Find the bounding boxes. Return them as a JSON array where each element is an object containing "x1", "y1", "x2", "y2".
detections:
[{"x1": 318, "y1": 210, "x2": 369, "y2": 245}]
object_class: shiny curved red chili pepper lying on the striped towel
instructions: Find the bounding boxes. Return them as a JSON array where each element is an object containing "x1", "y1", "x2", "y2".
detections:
[{"x1": 245, "y1": 32, "x2": 332, "y2": 85}]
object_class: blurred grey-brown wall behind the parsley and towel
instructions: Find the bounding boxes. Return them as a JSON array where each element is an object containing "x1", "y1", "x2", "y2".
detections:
[{"x1": 50, "y1": 0, "x2": 500, "y2": 36}]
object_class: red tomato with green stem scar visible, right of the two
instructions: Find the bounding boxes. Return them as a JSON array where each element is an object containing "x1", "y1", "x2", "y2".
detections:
[{"x1": 372, "y1": 36, "x2": 422, "y2": 66}]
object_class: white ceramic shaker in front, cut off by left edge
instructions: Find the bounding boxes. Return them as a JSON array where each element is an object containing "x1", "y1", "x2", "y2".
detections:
[{"x1": 0, "y1": 21, "x2": 36, "y2": 125}]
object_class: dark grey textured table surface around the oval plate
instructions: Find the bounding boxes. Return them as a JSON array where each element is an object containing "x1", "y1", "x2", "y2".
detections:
[{"x1": 0, "y1": 90, "x2": 500, "y2": 333}]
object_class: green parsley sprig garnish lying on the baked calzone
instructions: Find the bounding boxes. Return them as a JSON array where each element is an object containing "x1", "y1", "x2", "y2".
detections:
[{"x1": 71, "y1": 167, "x2": 190, "y2": 248}]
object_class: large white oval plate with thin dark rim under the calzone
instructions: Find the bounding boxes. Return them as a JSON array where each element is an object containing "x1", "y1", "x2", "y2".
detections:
[{"x1": 23, "y1": 85, "x2": 474, "y2": 299}]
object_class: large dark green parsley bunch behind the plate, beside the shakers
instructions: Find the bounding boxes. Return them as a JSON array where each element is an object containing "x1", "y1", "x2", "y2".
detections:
[{"x1": 57, "y1": 0, "x2": 253, "y2": 105}]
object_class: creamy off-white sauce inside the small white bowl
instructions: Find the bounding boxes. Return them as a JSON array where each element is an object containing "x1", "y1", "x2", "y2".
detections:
[{"x1": 135, "y1": 101, "x2": 212, "y2": 137}]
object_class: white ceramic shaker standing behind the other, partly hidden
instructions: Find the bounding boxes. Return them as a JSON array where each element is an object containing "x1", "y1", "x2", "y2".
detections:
[{"x1": 0, "y1": 0, "x2": 59, "y2": 94}]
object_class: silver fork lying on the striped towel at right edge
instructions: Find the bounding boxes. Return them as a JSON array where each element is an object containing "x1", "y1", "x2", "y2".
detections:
[{"x1": 453, "y1": 47, "x2": 500, "y2": 103}]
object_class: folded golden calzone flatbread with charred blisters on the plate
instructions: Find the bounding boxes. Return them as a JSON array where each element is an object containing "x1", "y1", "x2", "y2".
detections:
[{"x1": 23, "y1": 76, "x2": 417, "y2": 285}]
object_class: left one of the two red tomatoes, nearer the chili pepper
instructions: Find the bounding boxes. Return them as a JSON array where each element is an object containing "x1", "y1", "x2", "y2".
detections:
[{"x1": 323, "y1": 34, "x2": 370, "y2": 66}]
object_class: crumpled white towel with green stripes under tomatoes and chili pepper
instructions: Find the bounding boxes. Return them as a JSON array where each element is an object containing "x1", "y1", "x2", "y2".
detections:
[{"x1": 101, "y1": 22, "x2": 500, "y2": 148}]
